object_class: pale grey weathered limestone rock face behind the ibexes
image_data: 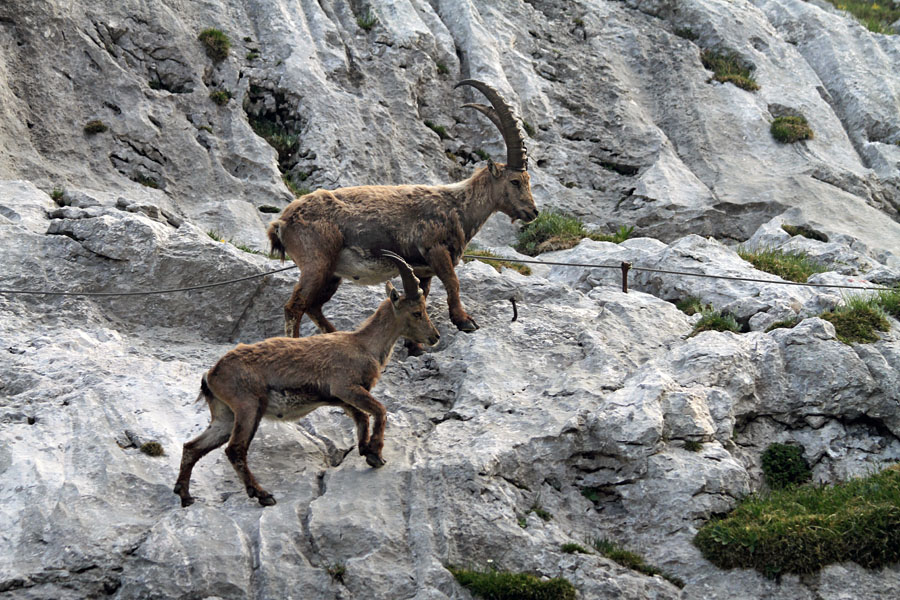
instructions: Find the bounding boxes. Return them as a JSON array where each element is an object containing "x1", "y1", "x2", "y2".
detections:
[{"x1": 0, "y1": 0, "x2": 900, "y2": 600}]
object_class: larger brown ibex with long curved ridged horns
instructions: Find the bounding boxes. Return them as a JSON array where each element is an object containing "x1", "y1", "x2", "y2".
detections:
[{"x1": 268, "y1": 79, "x2": 538, "y2": 353}]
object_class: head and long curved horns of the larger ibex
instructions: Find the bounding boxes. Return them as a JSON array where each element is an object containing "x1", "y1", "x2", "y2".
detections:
[{"x1": 454, "y1": 79, "x2": 538, "y2": 223}]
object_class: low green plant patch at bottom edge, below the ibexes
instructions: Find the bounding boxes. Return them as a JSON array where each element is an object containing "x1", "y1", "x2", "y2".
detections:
[{"x1": 448, "y1": 567, "x2": 575, "y2": 600}]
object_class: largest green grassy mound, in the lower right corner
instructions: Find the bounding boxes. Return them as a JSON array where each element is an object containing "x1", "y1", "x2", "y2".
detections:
[{"x1": 694, "y1": 465, "x2": 900, "y2": 578}]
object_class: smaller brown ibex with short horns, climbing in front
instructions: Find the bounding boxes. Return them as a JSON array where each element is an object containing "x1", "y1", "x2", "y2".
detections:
[{"x1": 174, "y1": 252, "x2": 440, "y2": 506}]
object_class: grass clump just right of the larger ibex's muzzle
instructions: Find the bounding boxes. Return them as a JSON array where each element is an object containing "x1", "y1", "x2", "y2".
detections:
[{"x1": 515, "y1": 211, "x2": 634, "y2": 256}]
